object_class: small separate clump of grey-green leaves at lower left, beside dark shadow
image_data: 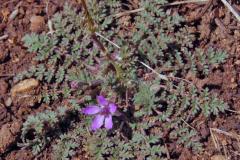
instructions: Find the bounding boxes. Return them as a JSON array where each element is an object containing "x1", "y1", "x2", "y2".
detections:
[{"x1": 19, "y1": 107, "x2": 68, "y2": 155}]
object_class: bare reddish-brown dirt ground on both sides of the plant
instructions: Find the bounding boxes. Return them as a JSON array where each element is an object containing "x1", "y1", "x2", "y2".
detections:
[{"x1": 0, "y1": 0, "x2": 240, "y2": 160}]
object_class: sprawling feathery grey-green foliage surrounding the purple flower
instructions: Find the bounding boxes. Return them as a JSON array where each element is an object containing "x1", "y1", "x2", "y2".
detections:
[{"x1": 18, "y1": 0, "x2": 227, "y2": 160}]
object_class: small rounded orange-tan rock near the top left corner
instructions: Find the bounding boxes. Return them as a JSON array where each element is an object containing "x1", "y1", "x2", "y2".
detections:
[{"x1": 30, "y1": 16, "x2": 45, "y2": 32}]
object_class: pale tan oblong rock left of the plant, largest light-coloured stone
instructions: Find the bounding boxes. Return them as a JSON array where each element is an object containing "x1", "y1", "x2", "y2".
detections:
[{"x1": 11, "y1": 78, "x2": 39, "y2": 99}]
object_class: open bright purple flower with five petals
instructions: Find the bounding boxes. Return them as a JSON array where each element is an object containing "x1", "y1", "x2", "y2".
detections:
[{"x1": 82, "y1": 96, "x2": 117, "y2": 131}]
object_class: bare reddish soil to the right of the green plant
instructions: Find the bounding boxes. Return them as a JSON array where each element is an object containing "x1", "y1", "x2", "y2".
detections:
[{"x1": 178, "y1": 0, "x2": 240, "y2": 160}]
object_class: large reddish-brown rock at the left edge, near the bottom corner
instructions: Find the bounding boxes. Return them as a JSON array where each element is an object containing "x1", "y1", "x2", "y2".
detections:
[{"x1": 0, "y1": 121, "x2": 22, "y2": 154}]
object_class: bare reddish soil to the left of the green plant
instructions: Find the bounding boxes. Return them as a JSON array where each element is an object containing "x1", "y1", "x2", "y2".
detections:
[{"x1": 0, "y1": 0, "x2": 64, "y2": 160}]
